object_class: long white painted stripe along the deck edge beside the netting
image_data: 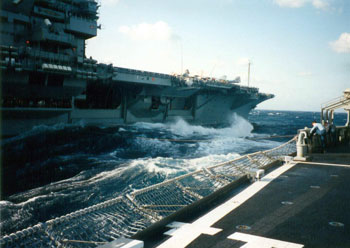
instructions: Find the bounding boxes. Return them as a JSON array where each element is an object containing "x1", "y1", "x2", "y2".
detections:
[{"x1": 158, "y1": 162, "x2": 296, "y2": 248}]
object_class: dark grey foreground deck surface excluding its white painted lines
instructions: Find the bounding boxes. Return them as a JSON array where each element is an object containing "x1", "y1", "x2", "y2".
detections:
[{"x1": 145, "y1": 144, "x2": 350, "y2": 247}]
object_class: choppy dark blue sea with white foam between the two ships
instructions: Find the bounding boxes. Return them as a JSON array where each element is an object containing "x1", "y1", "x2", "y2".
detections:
[{"x1": 0, "y1": 110, "x2": 346, "y2": 235}]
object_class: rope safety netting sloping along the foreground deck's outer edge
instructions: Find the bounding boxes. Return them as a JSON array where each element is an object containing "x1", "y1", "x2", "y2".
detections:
[{"x1": 0, "y1": 137, "x2": 296, "y2": 247}]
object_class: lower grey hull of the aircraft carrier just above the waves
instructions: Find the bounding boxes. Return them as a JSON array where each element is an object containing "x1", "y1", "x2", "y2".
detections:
[{"x1": 1, "y1": 94, "x2": 266, "y2": 137}]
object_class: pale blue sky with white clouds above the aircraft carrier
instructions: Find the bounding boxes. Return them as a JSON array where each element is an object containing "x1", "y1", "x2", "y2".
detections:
[{"x1": 86, "y1": 0, "x2": 350, "y2": 111}]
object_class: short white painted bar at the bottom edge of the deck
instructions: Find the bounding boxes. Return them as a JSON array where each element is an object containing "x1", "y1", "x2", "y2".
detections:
[{"x1": 227, "y1": 232, "x2": 304, "y2": 248}]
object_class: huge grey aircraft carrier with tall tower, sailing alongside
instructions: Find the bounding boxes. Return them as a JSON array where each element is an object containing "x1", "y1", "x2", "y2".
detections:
[{"x1": 0, "y1": 0, "x2": 273, "y2": 136}]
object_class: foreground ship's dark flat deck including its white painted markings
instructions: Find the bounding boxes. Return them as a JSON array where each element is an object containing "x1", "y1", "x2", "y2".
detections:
[{"x1": 140, "y1": 145, "x2": 350, "y2": 247}]
